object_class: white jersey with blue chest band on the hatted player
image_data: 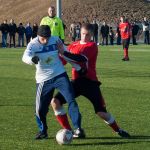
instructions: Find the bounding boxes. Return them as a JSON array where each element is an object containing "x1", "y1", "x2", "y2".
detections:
[{"x1": 22, "y1": 36, "x2": 65, "y2": 83}]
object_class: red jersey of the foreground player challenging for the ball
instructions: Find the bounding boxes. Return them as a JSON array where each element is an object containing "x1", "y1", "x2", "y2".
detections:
[{"x1": 68, "y1": 41, "x2": 98, "y2": 81}]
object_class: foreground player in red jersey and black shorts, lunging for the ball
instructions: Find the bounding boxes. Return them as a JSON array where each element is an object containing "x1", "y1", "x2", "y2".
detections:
[{"x1": 51, "y1": 24, "x2": 130, "y2": 138}]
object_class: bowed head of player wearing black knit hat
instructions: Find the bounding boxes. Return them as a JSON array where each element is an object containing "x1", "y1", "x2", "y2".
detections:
[{"x1": 37, "y1": 25, "x2": 51, "y2": 45}]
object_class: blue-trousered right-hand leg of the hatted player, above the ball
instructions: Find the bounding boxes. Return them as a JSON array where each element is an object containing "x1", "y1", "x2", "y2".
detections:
[{"x1": 55, "y1": 73, "x2": 81, "y2": 129}]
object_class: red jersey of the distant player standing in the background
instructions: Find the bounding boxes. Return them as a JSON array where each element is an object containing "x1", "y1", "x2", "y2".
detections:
[{"x1": 119, "y1": 22, "x2": 131, "y2": 39}]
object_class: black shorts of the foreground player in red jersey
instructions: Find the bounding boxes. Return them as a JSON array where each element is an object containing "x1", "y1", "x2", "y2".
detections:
[{"x1": 55, "y1": 78, "x2": 107, "y2": 113}]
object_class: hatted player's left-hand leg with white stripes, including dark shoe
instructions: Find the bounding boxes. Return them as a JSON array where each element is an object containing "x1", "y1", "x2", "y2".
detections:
[{"x1": 35, "y1": 81, "x2": 54, "y2": 139}]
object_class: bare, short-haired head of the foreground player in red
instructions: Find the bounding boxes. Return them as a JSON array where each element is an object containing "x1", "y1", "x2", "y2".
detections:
[{"x1": 81, "y1": 23, "x2": 93, "y2": 42}]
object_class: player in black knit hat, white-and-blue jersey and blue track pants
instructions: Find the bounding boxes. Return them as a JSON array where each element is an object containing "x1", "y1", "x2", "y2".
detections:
[{"x1": 22, "y1": 25, "x2": 86, "y2": 139}]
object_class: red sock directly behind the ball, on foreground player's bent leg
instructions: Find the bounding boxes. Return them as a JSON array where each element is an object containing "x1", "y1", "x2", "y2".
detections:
[{"x1": 56, "y1": 114, "x2": 71, "y2": 130}]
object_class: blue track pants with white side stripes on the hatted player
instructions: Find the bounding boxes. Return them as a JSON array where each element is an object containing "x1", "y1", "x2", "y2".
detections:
[{"x1": 36, "y1": 73, "x2": 81, "y2": 132}]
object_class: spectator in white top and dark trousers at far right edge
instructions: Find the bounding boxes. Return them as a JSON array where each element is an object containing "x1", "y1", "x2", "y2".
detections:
[{"x1": 142, "y1": 17, "x2": 150, "y2": 44}]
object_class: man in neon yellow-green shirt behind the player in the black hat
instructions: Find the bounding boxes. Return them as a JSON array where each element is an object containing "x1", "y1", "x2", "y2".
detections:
[{"x1": 40, "y1": 6, "x2": 65, "y2": 43}]
